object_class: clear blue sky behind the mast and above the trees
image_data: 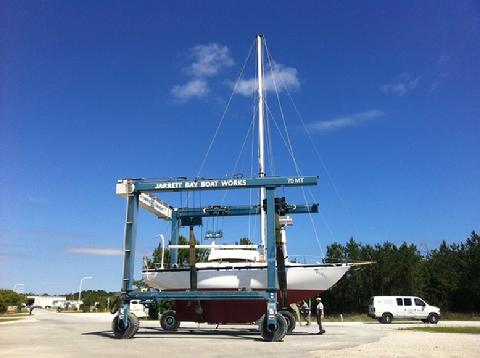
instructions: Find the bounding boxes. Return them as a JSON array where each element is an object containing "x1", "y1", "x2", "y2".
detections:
[{"x1": 0, "y1": 1, "x2": 480, "y2": 293}]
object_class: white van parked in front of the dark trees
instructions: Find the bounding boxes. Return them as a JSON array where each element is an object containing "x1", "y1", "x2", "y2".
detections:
[{"x1": 368, "y1": 296, "x2": 440, "y2": 324}]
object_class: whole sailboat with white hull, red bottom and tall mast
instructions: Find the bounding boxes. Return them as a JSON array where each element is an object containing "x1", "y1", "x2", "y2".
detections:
[{"x1": 142, "y1": 35, "x2": 352, "y2": 329}]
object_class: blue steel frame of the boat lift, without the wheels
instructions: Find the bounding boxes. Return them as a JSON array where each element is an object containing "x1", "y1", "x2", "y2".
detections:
[{"x1": 119, "y1": 176, "x2": 318, "y2": 332}]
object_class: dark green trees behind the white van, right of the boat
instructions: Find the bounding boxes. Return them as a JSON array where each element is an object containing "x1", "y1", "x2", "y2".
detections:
[{"x1": 322, "y1": 231, "x2": 480, "y2": 313}]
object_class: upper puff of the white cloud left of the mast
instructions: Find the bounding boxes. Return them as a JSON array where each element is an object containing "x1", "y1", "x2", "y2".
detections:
[{"x1": 187, "y1": 43, "x2": 234, "y2": 77}]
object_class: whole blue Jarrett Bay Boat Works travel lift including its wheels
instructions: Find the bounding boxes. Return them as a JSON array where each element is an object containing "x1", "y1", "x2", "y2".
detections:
[{"x1": 112, "y1": 176, "x2": 318, "y2": 341}]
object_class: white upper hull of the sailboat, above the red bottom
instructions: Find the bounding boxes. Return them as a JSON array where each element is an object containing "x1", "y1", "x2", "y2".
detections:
[{"x1": 143, "y1": 263, "x2": 351, "y2": 291}]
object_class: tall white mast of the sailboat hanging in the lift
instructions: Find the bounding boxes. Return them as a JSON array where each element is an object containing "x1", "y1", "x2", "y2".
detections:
[{"x1": 257, "y1": 35, "x2": 267, "y2": 258}]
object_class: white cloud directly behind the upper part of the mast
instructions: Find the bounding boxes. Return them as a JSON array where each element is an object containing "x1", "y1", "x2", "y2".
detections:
[{"x1": 232, "y1": 63, "x2": 300, "y2": 96}]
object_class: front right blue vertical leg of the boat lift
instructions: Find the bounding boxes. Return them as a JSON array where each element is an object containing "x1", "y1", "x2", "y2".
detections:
[{"x1": 266, "y1": 187, "x2": 277, "y2": 325}]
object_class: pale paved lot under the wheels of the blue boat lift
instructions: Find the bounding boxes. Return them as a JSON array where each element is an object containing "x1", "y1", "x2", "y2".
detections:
[{"x1": 0, "y1": 309, "x2": 478, "y2": 358}]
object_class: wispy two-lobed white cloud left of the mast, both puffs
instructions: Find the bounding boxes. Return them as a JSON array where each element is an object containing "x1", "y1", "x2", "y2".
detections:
[{"x1": 171, "y1": 43, "x2": 235, "y2": 102}]
